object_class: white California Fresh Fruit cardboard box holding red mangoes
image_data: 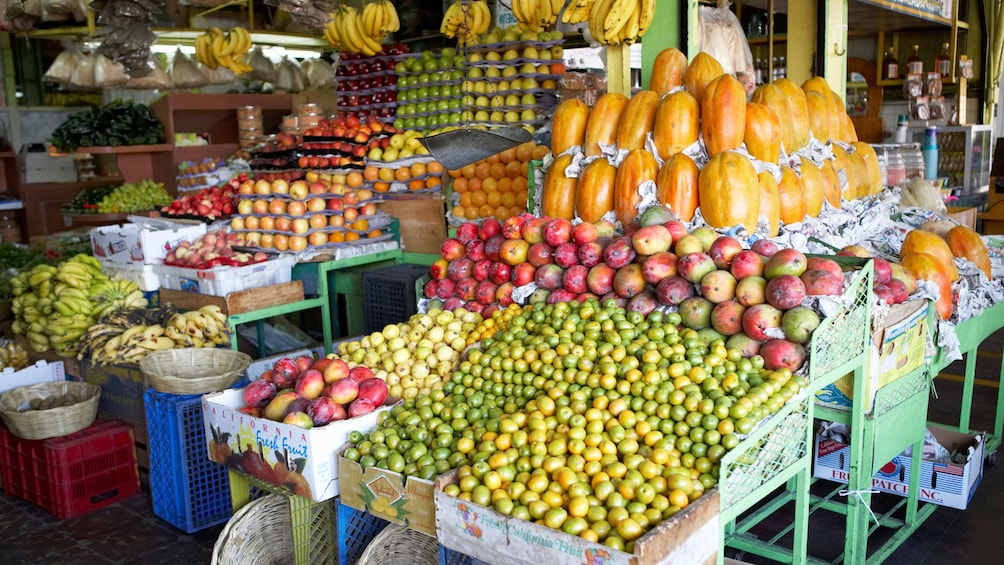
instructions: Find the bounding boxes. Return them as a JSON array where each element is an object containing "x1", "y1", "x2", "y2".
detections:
[{"x1": 202, "y1": 389, "x2": 397, "y2": 502}]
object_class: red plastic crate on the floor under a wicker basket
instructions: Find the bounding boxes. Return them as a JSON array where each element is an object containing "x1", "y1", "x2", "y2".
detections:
[{"x1": 0, "y1": 420, "x2": 140, "y2": 519}]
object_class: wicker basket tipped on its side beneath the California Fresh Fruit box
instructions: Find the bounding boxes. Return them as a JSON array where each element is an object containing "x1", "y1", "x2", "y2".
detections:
[{"x1": 212, "y1": 494, "x2": 294, "y2": 565}]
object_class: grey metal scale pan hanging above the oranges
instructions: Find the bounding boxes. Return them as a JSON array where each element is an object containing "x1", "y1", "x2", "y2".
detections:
[{"x1": 419, "y1": 125, "x2": 532, "y2": 169}]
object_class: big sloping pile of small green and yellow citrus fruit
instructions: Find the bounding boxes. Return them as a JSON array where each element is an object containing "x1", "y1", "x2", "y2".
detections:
[{"x1": 344, "y1": 299, "x2": 804, "y2": 552}]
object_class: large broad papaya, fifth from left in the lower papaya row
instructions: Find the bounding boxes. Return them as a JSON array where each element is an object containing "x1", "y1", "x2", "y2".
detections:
[{"x1": 698, "y1": 152, "x2": 760, "y2": 233}]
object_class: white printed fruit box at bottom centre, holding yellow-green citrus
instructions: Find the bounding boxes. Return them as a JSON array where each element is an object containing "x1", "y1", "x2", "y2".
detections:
[{"x1": 435, "y1": 472, "x2": 722, "y2": 565}]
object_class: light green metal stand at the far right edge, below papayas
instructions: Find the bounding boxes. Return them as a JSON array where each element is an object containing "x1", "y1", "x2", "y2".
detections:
[{"x1": 931, "y1": 303, "x2": 1004, "y2": 464}]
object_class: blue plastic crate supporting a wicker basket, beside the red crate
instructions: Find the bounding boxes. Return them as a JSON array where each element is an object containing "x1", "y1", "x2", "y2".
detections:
[{"x1": 144, "y1": 388, "x2": 239, "y2": 534}]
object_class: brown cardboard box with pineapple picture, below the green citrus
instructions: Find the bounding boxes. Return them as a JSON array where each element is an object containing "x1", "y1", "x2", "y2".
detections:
[{"x1": 338, "y1": 456, "x2": 436, "y2": 537}]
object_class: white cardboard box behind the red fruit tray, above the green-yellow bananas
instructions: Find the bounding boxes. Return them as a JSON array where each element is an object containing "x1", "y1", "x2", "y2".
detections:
[{"x1": 90, "y1": 222, "x2": 206, "y2": 264}]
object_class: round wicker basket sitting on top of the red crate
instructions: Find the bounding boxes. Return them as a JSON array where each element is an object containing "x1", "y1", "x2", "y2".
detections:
[{"x1": 0, "y1": 380, "x2": 101, "y2": 440}]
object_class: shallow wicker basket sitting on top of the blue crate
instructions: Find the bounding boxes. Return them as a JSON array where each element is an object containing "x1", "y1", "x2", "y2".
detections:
[{"x1": 140, "y1": 347, "x2": 251, "y2": 394}]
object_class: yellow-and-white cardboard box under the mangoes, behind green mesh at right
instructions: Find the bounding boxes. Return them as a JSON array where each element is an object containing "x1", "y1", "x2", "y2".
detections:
[{"x1": 816, "y1": 299, "x2": 932, "y2": 413}]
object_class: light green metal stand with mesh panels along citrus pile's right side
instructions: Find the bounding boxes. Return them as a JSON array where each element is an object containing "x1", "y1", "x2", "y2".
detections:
[{"x1": 718, "y1": 261, "x2": 873, "y2": 563}]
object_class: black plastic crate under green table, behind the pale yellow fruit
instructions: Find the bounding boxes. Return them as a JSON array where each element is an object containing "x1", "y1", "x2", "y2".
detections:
[{"x1": 362, "y1": 264, "x2": 429, "y2": 333}]
